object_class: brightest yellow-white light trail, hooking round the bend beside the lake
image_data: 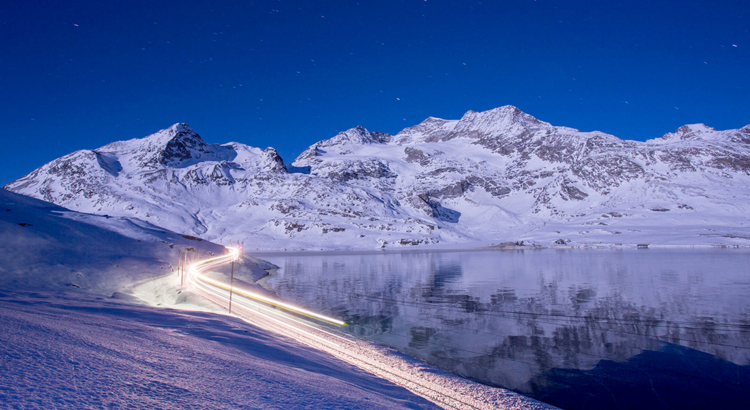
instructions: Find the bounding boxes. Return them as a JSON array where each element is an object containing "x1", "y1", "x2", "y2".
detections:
[{"x1": 188, "y1": 248, "x2": 347, "y2": 326}]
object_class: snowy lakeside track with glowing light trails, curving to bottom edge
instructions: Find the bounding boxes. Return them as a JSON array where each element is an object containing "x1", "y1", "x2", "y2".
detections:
[{"x1": 187, "y1": 248, "x2": 554, "y2": 409}]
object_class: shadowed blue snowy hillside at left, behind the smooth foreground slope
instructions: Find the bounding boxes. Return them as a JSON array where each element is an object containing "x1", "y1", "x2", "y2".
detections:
[{"x1": 0, "y1": 189, "x2": 229, "y2": 296}]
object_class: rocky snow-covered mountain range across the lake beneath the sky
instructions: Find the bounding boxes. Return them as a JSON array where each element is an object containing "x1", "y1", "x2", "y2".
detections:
[{"x1": 6, "y1": 106, "x2": 750, "y2": 249}]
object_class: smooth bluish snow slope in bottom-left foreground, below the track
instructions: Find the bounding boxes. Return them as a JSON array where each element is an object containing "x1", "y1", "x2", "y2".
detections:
[{"x1": 0, "y1": 293, "x2": 444, "y2": 409}]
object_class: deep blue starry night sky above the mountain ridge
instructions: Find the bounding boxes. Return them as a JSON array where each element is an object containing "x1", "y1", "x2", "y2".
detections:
[{"x1": 0, "y1": 0, "x2": 750, "y2": 185}]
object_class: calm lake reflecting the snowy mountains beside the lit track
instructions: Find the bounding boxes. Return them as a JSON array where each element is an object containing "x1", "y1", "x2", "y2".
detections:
[{"x1": 258, "y1": 249, "x2": 750, "y2": 409}]
